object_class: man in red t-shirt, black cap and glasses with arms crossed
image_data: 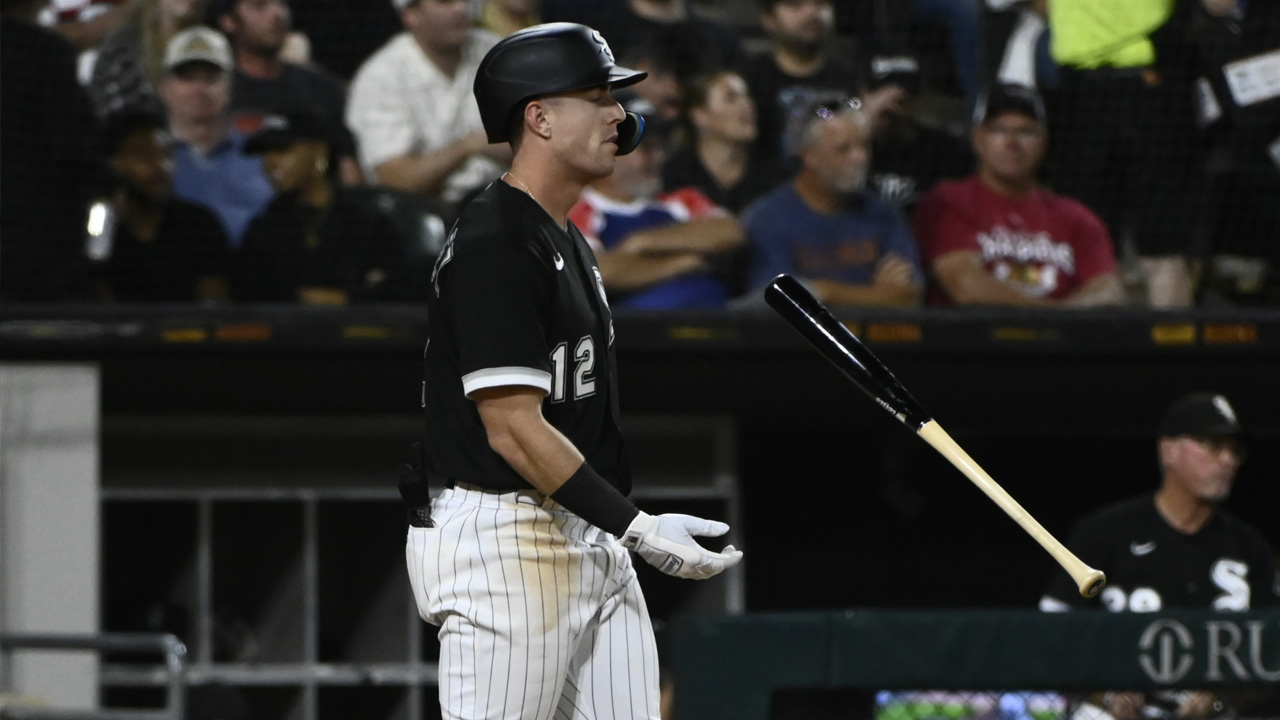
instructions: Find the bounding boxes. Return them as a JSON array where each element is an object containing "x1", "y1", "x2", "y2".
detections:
[{"x1": 915, "y1": 85, "x2": 1124, "y2": 307}]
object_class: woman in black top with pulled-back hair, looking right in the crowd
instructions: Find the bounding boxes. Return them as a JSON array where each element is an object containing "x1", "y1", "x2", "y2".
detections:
[{"x1": 663, "y1": 70, "x2": 785, "y2": 214}]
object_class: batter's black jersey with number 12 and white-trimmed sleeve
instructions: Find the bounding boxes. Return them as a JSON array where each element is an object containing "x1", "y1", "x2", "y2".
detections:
[{"x1": 422, "y1": 181, "x2": 631, "y2": 495}]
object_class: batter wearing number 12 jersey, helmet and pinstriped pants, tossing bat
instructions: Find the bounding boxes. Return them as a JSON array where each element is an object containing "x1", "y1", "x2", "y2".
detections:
[{"x1": 406, "y1": 23, "x2": 742, "y2": 720}]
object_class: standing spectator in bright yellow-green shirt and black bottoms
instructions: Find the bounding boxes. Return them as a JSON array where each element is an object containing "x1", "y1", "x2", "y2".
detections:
[{"x1": 1048, "y1": 0, "x2": 1206, "y2": 307}]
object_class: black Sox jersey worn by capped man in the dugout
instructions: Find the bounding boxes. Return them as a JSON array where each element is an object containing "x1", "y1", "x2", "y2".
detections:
[{"x1": 1041, "y1": 495, "x2": 1280, "y2": 612}]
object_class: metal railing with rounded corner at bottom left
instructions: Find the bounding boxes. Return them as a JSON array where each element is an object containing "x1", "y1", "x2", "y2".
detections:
[{"x1": 0, "y1": 633, "x2": 187, "y2": 720}]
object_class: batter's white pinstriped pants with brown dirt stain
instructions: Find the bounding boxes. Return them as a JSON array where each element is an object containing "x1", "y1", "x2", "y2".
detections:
[{"x1": 404, "y1": 487, "x2": 659, "y2": 720}]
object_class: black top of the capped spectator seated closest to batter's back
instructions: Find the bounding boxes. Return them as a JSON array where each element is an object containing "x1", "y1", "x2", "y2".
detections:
[{"x1": 232, "y1": 187, "x2": 402, "y2": 302}]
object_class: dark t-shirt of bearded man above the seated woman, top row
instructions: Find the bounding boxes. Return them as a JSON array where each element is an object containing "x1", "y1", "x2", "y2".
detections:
[{"x1": 744, "y1": 53, "x2": 865, "y2": 164}]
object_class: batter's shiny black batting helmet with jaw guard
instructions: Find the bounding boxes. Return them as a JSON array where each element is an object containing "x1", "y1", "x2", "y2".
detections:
[{"x1": 475, "y1": 23, "x2": 649, "y2": 155}]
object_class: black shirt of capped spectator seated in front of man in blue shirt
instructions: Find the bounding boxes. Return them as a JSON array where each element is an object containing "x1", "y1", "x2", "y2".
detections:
[{"x1": 95, "y1": 197, "x2": 232, "y2": 302}]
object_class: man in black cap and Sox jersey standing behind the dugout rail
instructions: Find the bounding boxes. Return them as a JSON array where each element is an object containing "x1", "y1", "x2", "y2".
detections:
[{"x1": 1039, "y1": 393, "x2": 1280, "y2": 720}]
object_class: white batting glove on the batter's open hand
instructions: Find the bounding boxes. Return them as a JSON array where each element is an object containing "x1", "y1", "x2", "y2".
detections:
[{"x1": 622, "y1": 512, "x2": 742, "y2": 580}]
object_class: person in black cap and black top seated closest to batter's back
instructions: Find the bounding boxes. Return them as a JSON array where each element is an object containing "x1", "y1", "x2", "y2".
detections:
[{"x1": 232, "y1": 114, "x2": 403, "y2": 305}]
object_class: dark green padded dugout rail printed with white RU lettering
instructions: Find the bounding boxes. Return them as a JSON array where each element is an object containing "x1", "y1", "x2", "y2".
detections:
[{"x1": 672, "y1": 609, "x2": 1280, "y2": 720}]
